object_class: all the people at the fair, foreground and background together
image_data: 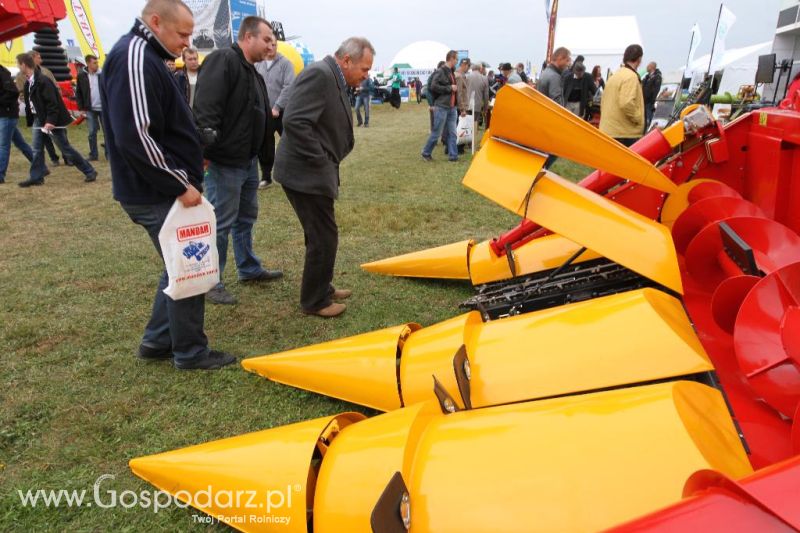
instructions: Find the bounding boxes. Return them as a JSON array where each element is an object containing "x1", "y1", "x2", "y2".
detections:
[{"x1": 0, "y1": 0, "x2": 660, "y2": 369}]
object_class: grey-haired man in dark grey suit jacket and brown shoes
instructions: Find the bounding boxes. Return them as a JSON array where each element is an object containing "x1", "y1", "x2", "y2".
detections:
[{"x1": 273, "y1": 37, "x2": 375, "y2": 318}]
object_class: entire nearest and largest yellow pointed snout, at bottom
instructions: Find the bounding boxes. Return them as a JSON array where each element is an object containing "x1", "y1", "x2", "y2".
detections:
[{"x1": 131, "y1": 382, "x2": 752, "y2": 533}]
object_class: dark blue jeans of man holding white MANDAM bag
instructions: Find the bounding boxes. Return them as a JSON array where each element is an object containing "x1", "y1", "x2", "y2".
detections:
[{"x1": 122, "y1": 202, "x2": 208, "y2": 361}]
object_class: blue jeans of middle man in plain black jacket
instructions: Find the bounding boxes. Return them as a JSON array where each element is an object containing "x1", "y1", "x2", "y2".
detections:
[{"x1": 205, "y1": 157, "x2": 264, "y2": 287}]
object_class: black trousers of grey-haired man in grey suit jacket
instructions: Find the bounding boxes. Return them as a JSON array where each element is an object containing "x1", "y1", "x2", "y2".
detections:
[{"x1": 283, "y1": 187, "x2": 339, "y2": 312}]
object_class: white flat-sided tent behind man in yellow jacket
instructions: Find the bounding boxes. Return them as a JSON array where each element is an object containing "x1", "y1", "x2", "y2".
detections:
[{"x1": 555, "y1": 16, "x2": 647, "y2": 78}]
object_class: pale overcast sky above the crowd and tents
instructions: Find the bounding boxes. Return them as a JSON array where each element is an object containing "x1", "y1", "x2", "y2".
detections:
[{"x1": 60, "y1": 0, "x2": 780, "y2": 71}]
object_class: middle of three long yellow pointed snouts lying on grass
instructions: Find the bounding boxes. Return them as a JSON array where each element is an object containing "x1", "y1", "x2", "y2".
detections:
[{"x1": 242, "y1": 289, "x2": 713, "y2": 411}]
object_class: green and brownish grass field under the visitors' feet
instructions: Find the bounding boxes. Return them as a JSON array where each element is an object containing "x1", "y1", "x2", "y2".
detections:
[{"x1": 0, "y1": 103, "x2": 587, "y2": 531}]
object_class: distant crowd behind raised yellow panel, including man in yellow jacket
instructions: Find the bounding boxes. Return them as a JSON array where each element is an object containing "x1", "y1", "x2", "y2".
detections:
[{"x1": 422, "y1": 44, "x2": 662, "y2": 160}]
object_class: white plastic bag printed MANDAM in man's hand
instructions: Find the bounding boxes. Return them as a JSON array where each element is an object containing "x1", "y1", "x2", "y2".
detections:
[{"x1": 158, "y1": 197, "x2": 219, "y2": 300}]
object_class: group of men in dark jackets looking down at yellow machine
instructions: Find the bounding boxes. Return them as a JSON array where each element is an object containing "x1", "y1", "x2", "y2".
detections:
[{"x1": 90, "y1": 0, "x2": 375, "y2": 369}]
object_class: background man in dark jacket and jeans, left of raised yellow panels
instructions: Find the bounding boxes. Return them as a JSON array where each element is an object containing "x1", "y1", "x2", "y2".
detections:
[{"x1": 422, "y1": 50, "x2": 458, "y2": 161}]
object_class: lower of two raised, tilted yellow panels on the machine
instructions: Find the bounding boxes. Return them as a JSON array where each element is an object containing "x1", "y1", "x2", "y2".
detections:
[{"x1": 464, "y1": 139, "x2": 683, "y2": 293}]
